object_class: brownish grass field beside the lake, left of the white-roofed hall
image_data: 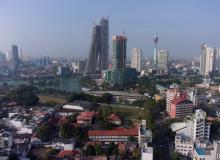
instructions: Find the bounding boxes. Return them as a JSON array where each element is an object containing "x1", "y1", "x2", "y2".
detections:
[{"x1": 38, "y1": 95, "x2": 67, "y2": 104}]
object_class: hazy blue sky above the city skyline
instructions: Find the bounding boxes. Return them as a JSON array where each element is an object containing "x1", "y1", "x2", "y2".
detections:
[{"x1": 0, "y1": 0, "x2": 220, "y2": 57}]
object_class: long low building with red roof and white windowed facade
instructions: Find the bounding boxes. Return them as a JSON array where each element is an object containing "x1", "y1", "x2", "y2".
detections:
[{"x1": 88, "y1": 128, "x2": 138, "y2": 143}]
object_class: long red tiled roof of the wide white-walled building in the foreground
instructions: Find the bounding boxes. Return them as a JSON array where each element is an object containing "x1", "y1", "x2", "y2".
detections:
[{"x1": 88, "y1": 128, "x2": 138, "y2": 136}]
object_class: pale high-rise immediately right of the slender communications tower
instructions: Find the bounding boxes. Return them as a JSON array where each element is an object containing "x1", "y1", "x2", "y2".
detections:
[{"x1": 157, "y1": 49, "x2": 169, "y2": 75}]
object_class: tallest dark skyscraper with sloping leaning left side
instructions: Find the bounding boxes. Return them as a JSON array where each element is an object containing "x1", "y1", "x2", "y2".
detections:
[{"x1": 85, "y1": 18, "x2": 109, "y2": 74}]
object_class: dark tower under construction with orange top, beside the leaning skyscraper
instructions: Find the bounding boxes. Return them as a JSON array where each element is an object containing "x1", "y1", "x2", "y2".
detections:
[{"x1": 112, "y1": 35, "x2": 127, "y2": 70}]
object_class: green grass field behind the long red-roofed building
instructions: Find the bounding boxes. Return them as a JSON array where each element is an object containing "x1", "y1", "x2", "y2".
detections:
[{"x1": 100, "y1": 105, "x2": 144, "y2": 120}]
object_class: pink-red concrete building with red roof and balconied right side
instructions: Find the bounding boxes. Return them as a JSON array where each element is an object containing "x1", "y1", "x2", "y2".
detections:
[{"x1": 169, "y1": 97, "x2": 193, "y2": 118}]
